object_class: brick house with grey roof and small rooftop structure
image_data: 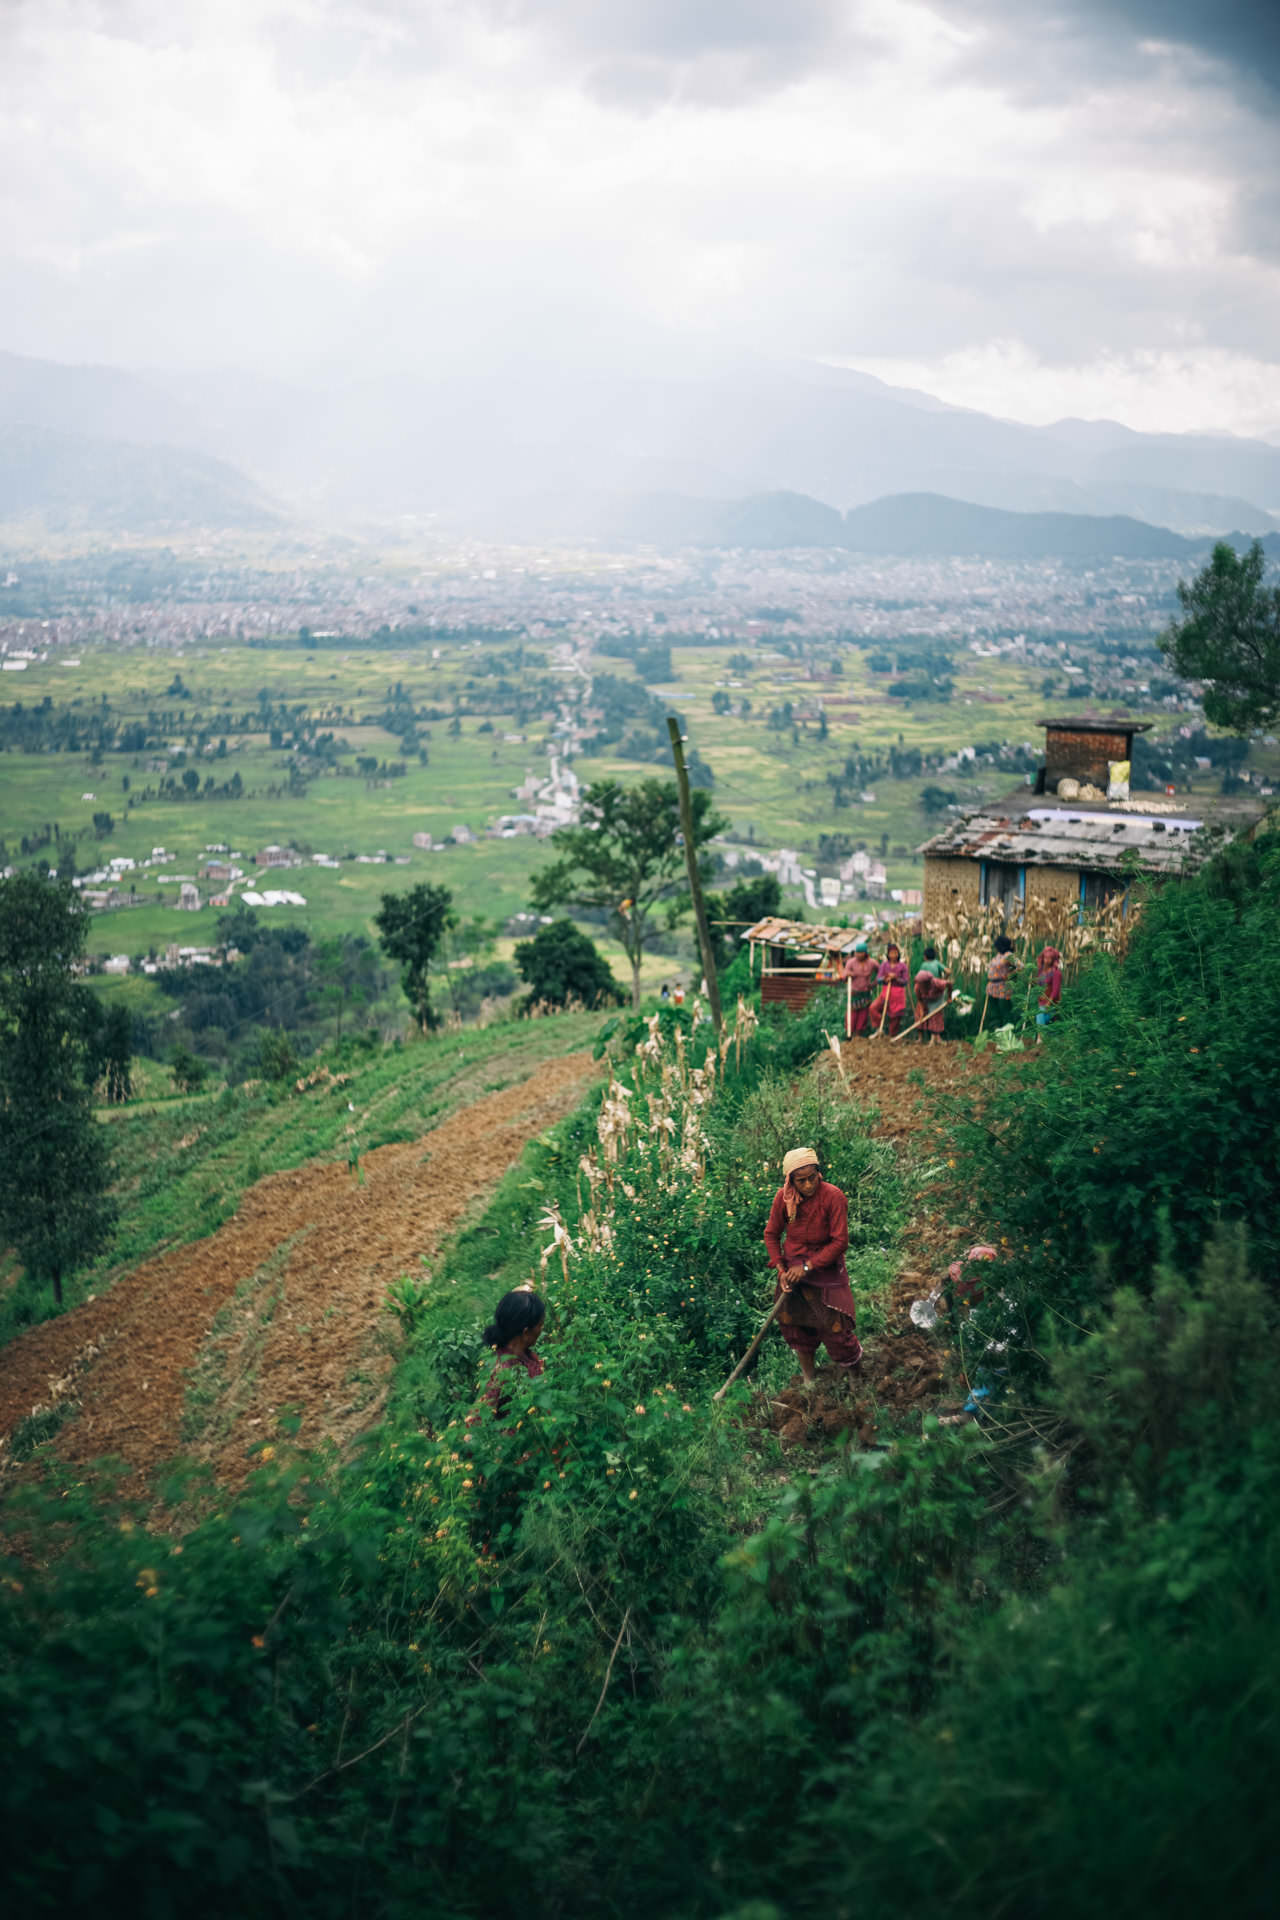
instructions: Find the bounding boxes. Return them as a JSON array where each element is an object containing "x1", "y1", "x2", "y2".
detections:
[{"x1": 919, "y1": 718, "x2": 1267, "y2": 925}]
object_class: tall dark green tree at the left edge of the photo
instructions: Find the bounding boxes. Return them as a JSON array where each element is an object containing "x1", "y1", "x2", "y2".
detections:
[{"x1": 0, "y1": 874, "x2": 115, "y2": 1304}]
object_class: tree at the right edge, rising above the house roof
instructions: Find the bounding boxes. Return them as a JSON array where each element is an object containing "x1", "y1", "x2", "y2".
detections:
[{"x1": 1159, "y1": 540, "x2": 1280, "y2": 733}]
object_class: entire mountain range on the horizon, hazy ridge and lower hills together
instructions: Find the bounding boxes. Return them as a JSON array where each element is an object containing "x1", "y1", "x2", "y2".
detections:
[{"x1": 0, "y1": 353, "x2": 1280, "y2": 551}]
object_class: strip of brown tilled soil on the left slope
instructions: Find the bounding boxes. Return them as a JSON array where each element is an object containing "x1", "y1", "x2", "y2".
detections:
[{"x1": 0, "y1": 1054, "x2": 599, "y2": 1490}]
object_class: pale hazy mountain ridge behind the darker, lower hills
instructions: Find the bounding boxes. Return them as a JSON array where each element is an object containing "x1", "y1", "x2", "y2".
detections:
[{"x1": 0, "y1": 353, "x2": 1280, "y2": 534}]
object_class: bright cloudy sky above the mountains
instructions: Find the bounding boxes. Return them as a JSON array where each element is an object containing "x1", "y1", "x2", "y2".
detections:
[{"x1": 0, "y1": 0, "x2": 1280, "y2": 432}]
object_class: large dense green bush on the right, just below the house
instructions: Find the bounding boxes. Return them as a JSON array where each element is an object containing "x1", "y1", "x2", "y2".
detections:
[{"x1": 958, "y1": 839, "x2": 1280, "y2": 1311}]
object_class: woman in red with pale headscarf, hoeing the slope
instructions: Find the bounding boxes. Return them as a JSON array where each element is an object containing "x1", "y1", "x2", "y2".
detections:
[{"x1": 764, "y1": 1146, "x2": 862, "y2": 1380}]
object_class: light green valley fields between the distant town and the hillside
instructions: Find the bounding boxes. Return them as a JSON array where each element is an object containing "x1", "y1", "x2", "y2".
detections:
[{"x1": 0, "y1": 618, "x2": 1243, "y2": 985}]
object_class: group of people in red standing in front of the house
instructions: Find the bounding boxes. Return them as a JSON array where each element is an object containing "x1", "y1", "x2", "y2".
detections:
[{"x1": 818, "y1": 933, "x2": 1063, "y2": 1044}]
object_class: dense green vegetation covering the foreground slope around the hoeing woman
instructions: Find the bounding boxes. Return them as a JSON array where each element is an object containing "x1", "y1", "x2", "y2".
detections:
[{"x1": 0, "y1": 833, "x2": 1280, "y2": 1920}]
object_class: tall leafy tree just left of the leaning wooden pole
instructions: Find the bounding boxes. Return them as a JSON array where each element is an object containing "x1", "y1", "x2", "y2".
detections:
[{"x1": 530, "y1": 780, "x2": 723, "y2": 1006}]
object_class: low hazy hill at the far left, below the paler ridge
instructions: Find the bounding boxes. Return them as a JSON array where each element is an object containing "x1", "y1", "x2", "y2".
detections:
[{"x1": 0, "y1": 426, "x2": 280, "y2": 532}]
